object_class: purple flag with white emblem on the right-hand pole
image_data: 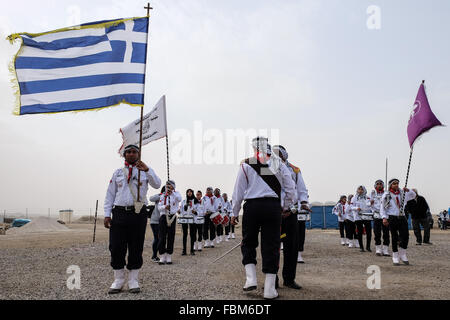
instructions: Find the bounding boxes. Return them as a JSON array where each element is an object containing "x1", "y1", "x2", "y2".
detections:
[{"x1": 408, "y1": 82, "x2": 442, "y2": 147}]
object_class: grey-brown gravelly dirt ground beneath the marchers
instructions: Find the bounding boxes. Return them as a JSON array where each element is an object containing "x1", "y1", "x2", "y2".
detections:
[{"x1": 0, "y1": 224, "x2": 450, "y2": 300}]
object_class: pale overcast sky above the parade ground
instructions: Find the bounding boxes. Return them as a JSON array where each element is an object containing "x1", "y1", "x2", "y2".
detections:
[{"x1": 0, "y1": 0, "x2": 450, "y2": 218}]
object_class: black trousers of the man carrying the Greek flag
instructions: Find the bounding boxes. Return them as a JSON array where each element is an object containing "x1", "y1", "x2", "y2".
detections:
[{"x1": 109, "y1": 207, "x2": 147, "y2": 270}]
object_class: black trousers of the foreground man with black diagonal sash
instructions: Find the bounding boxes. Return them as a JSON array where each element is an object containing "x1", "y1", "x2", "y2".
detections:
[{"x1": 241, "y1": 198, "x2": 281, "y2": 274}]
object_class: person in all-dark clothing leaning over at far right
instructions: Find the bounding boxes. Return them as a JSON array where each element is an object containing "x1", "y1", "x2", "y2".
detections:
[{"x1": 405, "y1": 189, "x2": 432, "y2": 245}]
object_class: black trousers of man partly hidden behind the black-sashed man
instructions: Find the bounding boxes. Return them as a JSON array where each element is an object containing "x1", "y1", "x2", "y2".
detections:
[{"x1": 281, "y1": 214, "x2": 300, "y2": 282}]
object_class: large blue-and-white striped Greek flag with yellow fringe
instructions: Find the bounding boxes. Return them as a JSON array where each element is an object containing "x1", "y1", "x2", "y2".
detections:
[{"x1": 8, "y1": 17, "x2": 148, "y2": 115}]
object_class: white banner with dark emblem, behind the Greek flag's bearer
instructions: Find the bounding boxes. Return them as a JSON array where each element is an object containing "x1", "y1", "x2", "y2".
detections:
[{"x1": 119, "y1": 96, "x2": 167, "y2": 155}]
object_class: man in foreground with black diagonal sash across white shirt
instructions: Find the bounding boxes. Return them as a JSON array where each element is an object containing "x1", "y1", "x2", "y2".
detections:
[{"x1": 231, "y1": 137, "x2": 297, "y2": 299}]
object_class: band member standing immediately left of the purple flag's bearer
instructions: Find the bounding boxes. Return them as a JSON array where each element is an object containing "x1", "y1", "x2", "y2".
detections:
[{"x1": 370, "y1": 180, "x2": 390, "y2": 257}]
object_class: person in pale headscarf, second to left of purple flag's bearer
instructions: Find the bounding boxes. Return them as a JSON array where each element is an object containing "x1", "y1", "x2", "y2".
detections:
[{"x1": 352, "y1": 186, "x2": 372, "y2": 252}]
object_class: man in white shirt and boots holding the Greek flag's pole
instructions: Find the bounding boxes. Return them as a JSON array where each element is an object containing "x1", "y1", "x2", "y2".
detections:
[{"x1": 104, "y1": 145, "x2": 161, "y2": 294}]
